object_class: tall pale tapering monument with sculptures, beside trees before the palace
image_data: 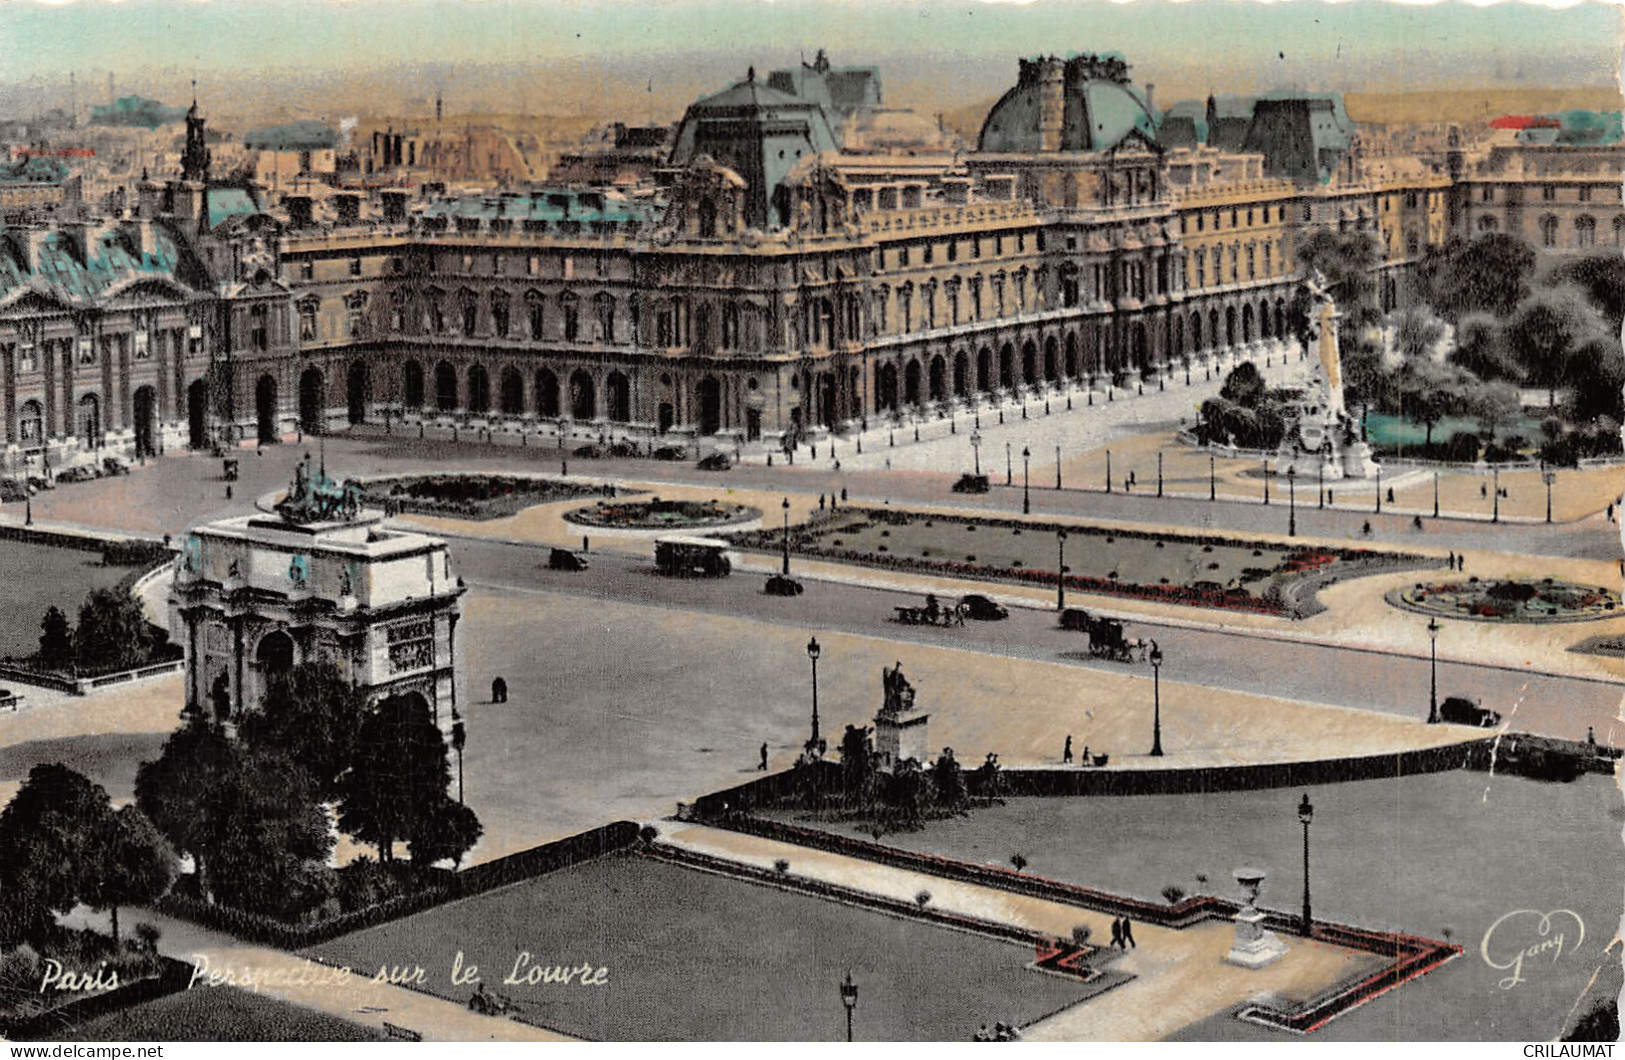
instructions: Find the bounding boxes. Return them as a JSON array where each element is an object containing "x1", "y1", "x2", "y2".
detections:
[{"x1": 1274, "y1": 272, "x2": 1376, "y2": 481}]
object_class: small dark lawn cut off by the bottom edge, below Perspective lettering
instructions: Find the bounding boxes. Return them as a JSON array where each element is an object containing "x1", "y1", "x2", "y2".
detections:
[{"x1": 54, "y1": 987, "x2": 380, "y2": 1042}]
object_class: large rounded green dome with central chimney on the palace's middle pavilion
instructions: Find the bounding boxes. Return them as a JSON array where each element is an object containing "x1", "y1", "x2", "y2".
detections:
[{"x1": 978, "y1": 57, "x2": 1157, "y2": 153}]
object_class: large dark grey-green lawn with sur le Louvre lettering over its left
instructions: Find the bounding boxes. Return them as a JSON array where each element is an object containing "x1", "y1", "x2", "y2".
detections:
[{"x1": 314, "y1": 855, "x2": 1087, "y2": 1042}]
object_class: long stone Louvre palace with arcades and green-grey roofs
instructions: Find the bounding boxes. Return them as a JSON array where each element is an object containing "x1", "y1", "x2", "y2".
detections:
[{"x1": 0, "y1": 55, "x2": 1625, "y2": 468}]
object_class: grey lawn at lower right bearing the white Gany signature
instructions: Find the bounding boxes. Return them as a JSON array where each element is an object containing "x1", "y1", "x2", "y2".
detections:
[{"x1": 763, "y1": 772, "x2": 1625, "y2": 1040}]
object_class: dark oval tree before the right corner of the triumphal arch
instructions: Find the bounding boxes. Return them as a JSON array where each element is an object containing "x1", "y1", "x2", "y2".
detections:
[{"x1": 338, "y1": 696, "x2": 452, "y2": 862}]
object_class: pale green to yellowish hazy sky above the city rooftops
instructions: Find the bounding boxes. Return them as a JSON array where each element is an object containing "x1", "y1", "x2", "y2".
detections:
[{"x1": 0, "y1": 0, "x2": 1625, "y2": 118}]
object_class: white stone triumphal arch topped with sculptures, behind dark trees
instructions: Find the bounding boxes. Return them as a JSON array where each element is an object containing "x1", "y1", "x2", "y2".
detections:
[{"x1": 169, "y1": 455, "x2": 465, "y2": 732}]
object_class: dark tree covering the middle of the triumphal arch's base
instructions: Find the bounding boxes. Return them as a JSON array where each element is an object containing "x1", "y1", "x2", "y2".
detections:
[{"x1": 242, "y1": 658, "x2": 366, "y2": 800}]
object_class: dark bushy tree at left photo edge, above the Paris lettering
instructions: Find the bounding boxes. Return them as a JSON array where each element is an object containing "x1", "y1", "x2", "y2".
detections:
[{"x1": 0, "y1": 762, "x2": 112, "y2": 943}]
